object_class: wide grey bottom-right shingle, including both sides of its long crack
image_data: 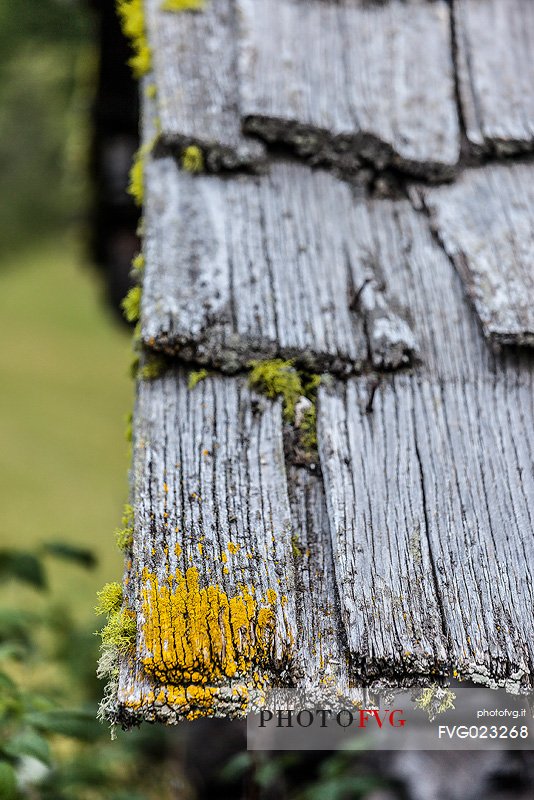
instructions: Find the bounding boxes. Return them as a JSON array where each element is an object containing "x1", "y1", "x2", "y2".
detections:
[{"x1": 318, "y1": 372, "x2": 534, "y2": 691}]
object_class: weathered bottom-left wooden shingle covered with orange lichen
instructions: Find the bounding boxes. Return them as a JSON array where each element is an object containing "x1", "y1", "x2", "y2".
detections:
[{"x1": 119, "y1": 370, "x2": 298, "y2": 721}]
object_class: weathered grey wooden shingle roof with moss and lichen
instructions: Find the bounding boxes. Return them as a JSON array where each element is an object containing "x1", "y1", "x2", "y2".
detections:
[{"x1": 111, "y1": 0, "x2": 534, "y2": 724}]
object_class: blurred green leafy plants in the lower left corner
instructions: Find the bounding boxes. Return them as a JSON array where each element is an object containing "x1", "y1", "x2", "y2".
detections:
[{"x1": 0, "y1": 542, "x2": 182, "y2": 800}]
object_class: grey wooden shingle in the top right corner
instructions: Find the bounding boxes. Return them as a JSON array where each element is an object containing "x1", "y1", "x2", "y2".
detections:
[{"x1": 453, "y1": 0, "x2": 534, "y2": 155}]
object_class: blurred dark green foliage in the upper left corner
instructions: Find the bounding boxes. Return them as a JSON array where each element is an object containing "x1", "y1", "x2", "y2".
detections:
[{"x1": 0, "y1": 0, "x2": 94, "y2": 251}]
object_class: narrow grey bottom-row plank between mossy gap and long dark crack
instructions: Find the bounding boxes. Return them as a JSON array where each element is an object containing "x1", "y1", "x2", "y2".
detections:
[{"x1": 318, "y1": 376, "x2": 446, "y2": 685}]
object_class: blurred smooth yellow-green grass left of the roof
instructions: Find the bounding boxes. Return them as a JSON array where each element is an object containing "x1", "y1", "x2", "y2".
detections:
[{"x1": 0, "y1": 241, "x2": 133, "y2": 627}]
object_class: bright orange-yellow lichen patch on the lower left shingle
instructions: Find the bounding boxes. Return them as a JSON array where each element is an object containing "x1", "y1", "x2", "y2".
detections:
[{"x1": 142, "y1": 567, "x2": 277, "y2": 684}]
